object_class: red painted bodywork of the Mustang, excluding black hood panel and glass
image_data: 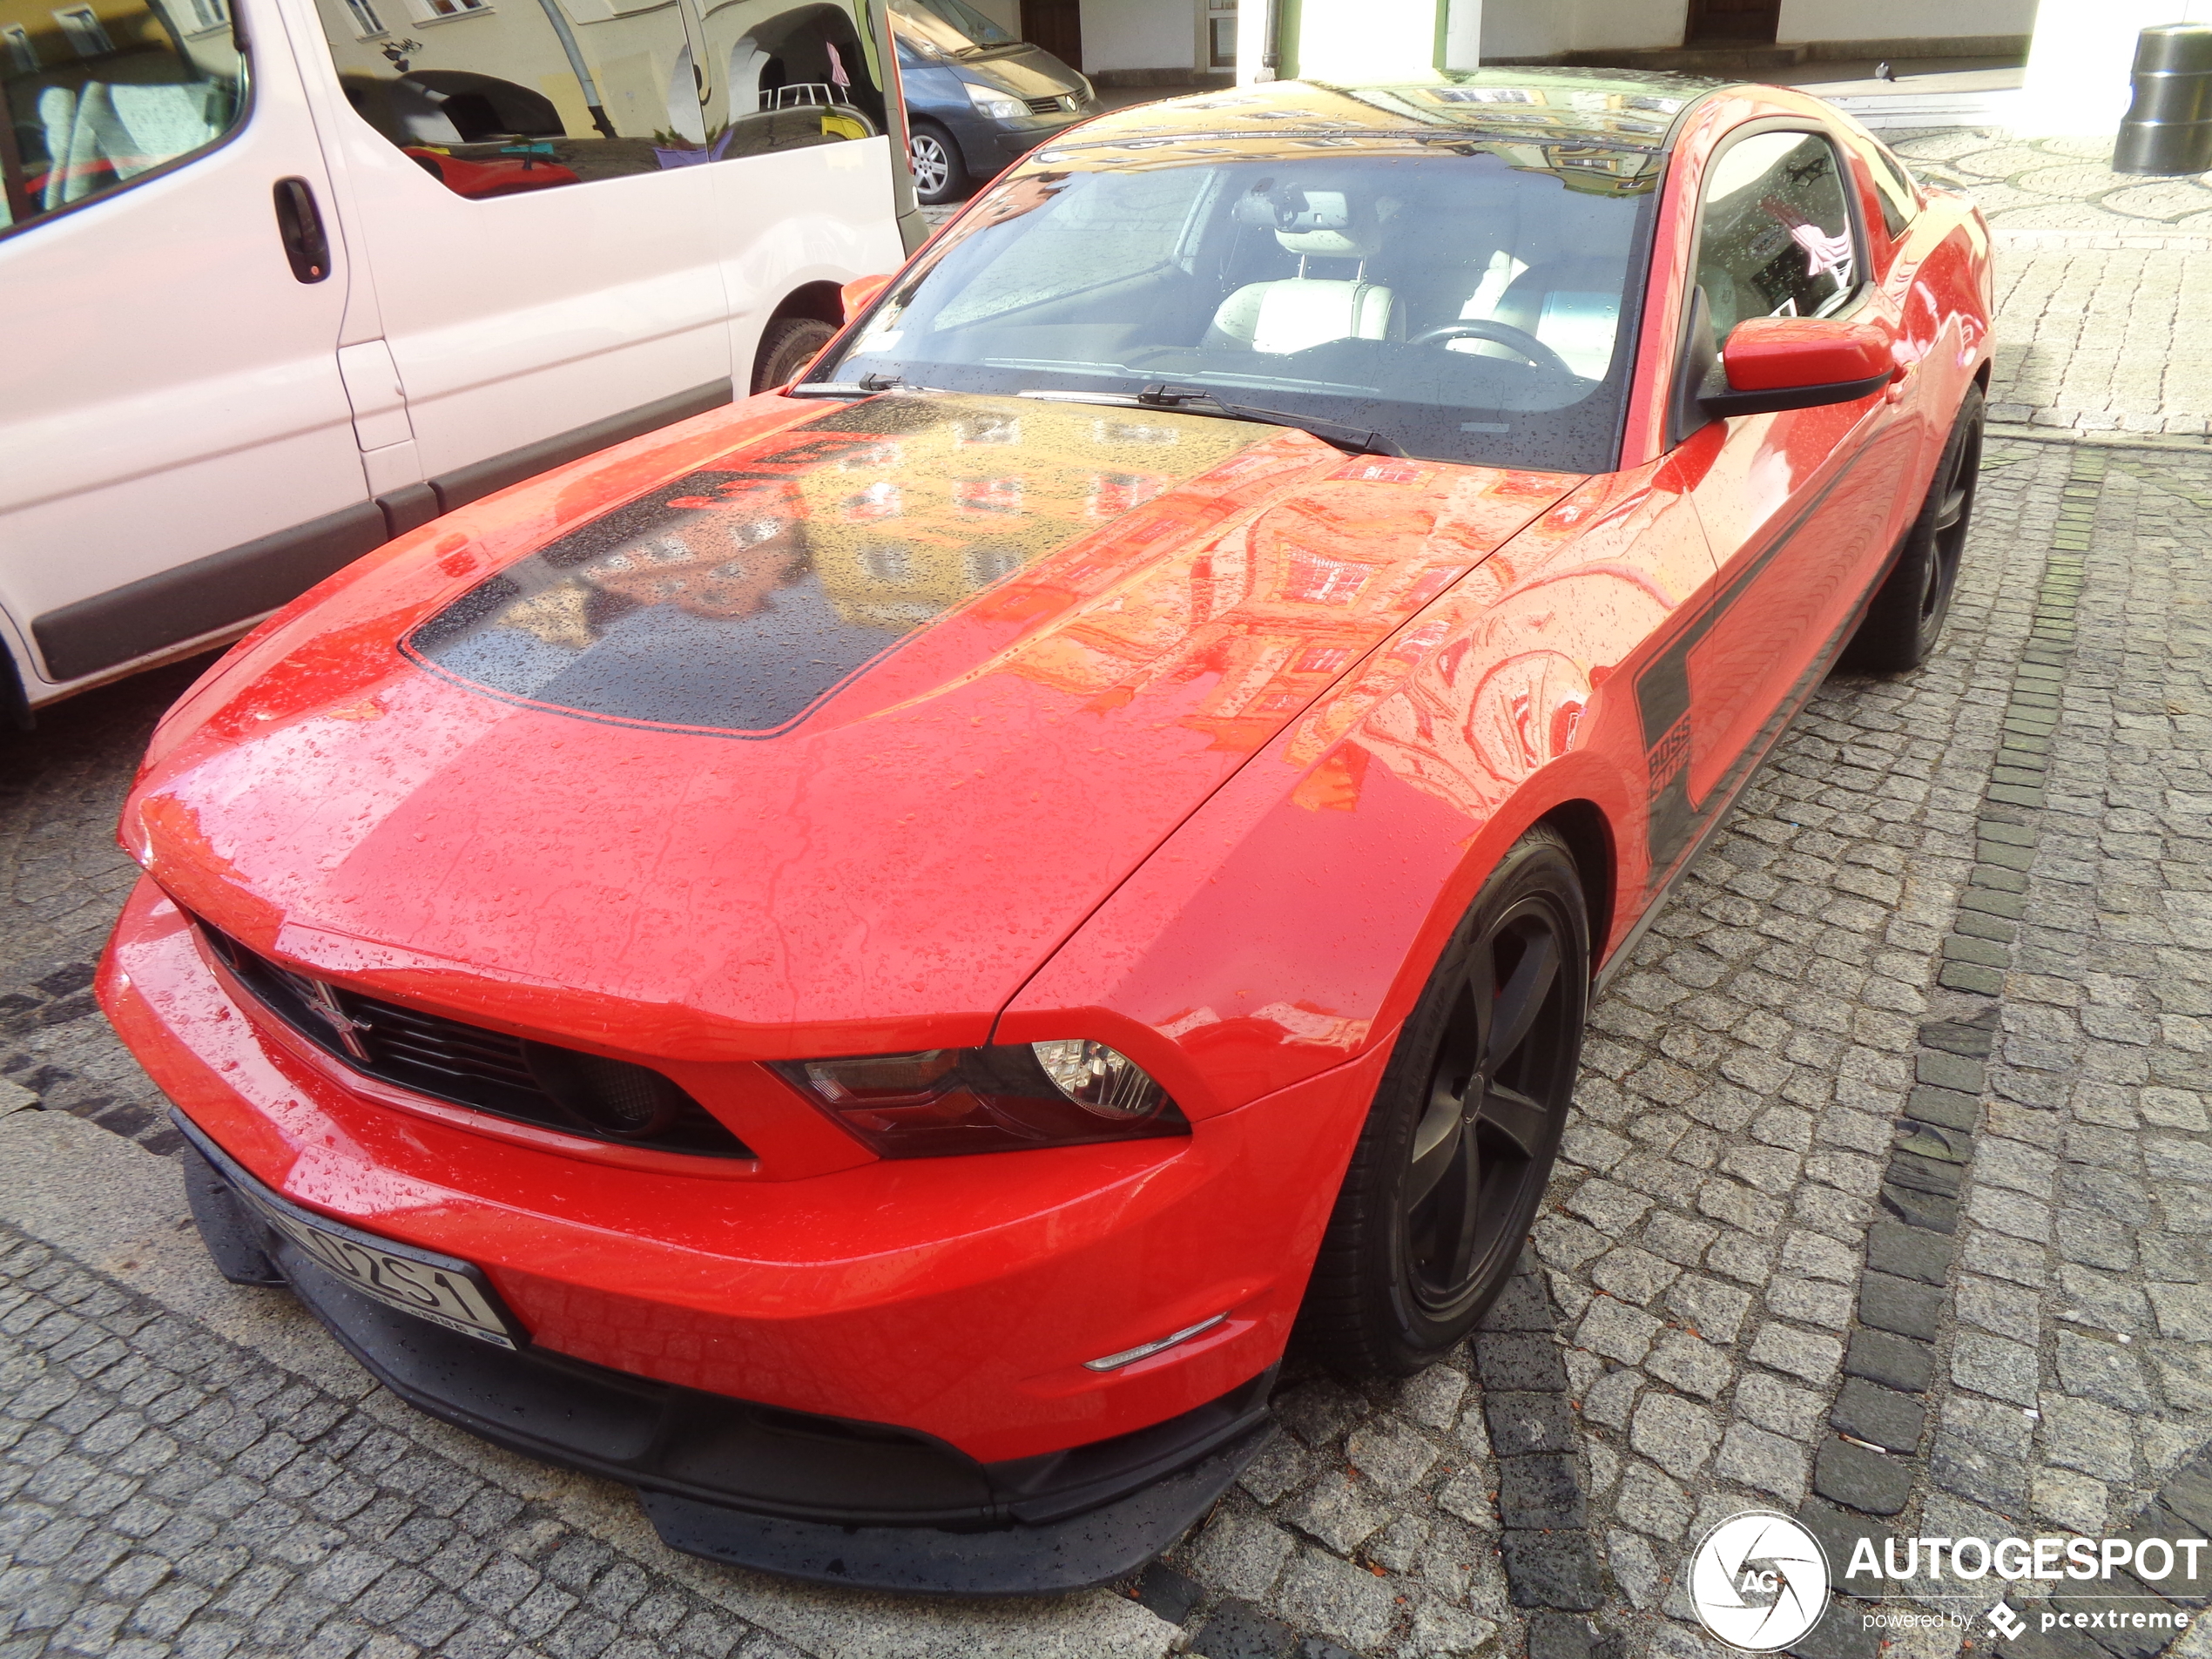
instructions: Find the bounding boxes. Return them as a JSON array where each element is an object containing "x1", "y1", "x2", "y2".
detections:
[{"x1": 102, "y1": 91, "x2": 1988, "y2": 1458}]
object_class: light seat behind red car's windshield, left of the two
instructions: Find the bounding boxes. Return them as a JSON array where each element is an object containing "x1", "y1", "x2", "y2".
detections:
[{"x1": 1205, "y1": 190, "x2": 1392, "y2": 354}]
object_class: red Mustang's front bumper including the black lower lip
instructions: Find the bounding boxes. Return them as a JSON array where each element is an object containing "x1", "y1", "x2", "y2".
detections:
[{"x1": 99, "y1": 882, "x2": 1383, "y2": 1593}]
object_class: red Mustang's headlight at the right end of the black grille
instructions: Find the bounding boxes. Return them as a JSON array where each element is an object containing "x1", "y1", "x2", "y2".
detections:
[{"x1": 774, "y1": 1040, "x2": 1190, "y2": 1157}]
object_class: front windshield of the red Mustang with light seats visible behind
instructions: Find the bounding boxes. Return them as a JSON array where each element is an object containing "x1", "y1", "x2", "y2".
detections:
[{"x1": 810, "y1": 139, "x2": 1656, "y2": 471}]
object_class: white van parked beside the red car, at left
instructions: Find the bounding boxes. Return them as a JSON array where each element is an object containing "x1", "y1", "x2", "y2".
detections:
[{"x1": 0, "y1": 0, "x2": 925, "y2": 724}]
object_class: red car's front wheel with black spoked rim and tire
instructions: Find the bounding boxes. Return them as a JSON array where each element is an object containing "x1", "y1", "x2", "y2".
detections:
[{"x1": 1298, "y1": 825, "x2": 1590, "y2": 1376}]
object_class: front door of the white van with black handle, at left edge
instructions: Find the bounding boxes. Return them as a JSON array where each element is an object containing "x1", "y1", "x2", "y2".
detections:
[{"x1": 0, "y1": 0, "x2": 388, "y2": 704}]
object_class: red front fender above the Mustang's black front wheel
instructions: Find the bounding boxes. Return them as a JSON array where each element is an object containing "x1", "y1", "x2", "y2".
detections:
[{"x1": 993, "y1": 462, "x2": 1712, "y2": 1117}]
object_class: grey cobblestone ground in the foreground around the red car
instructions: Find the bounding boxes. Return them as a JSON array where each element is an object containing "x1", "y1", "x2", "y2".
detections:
[{"x1": 0, "y1": 394, "x2": 2212, "y2": 1659}]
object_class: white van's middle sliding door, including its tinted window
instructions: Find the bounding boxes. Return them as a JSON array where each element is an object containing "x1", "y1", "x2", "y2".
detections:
[{"x1": 286, "y1": 0, "x2": 732, "y2": 524}]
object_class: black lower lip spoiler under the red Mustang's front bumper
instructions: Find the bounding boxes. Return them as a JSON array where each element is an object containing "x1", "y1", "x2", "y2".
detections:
[{"x1": 172, "y1": 1113, "x2": 1274, "y2": 1595}]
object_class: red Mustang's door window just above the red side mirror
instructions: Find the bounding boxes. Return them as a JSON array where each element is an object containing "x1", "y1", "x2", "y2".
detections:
[{"x1": 1696, "y1": 132, "x2": 1860, "y2": 341}]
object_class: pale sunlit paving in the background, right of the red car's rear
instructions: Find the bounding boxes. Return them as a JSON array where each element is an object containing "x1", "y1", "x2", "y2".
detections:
[{"x1": 1896, "y1": 131, "x2": 2212, "y2": 440}]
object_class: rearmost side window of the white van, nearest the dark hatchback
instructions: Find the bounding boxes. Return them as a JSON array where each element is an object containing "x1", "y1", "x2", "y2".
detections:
[{"x1": 701, "y1": 0, "x2": 885, "y2": 161}]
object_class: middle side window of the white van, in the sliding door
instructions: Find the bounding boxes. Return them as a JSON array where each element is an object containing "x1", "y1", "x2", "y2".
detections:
[{"x1": 316, "y1": 0, "x2": 710, "y2": 199}]
